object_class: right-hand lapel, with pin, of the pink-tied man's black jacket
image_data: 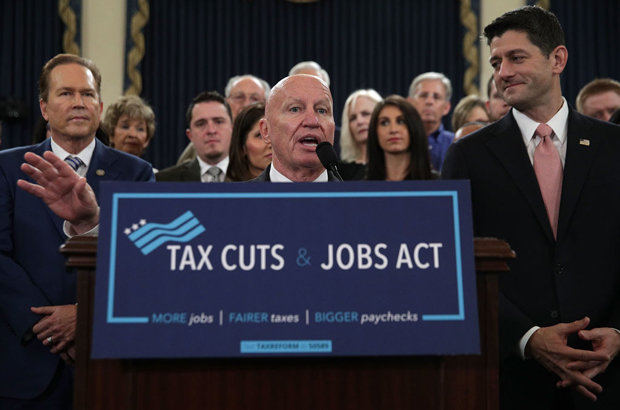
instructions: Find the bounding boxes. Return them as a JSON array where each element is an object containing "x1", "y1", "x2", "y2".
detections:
[{"x1": 558, "y1": 109, "x2": 600, "y2": 242}]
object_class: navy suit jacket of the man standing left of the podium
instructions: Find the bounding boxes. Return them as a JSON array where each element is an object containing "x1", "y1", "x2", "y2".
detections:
[{"x1": 0, "y1": 139, "x2": 154, "y2": 399}]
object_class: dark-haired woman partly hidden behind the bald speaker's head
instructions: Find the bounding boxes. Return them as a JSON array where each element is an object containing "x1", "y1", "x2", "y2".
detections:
[{"x1": 226, "y1": 102, "x2": 271, "y2": 182}]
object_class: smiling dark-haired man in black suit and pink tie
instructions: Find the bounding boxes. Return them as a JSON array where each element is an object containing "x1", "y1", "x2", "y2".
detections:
[{"x1": 443, "y1": 7, "x2": 620, "y2": 409}]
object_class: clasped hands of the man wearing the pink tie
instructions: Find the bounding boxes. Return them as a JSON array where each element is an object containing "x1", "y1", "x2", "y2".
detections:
[{"x1": 525, "y1": 317, "x2": 620, "y2": 401}]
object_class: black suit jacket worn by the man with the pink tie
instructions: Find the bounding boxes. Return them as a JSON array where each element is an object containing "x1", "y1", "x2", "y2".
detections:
[{"x1": 442, "y1": 109, "x2": 620, "y2": 409}]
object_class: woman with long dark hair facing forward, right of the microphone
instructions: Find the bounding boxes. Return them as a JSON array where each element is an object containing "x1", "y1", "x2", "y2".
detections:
[{"x1": 366, "y1": 95, "x2": 436, "y2": 181}]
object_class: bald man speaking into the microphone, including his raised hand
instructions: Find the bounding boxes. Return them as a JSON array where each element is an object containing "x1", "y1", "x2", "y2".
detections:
[{"x1": 18, "y1": 74, "x2": 336, "y2": 235}]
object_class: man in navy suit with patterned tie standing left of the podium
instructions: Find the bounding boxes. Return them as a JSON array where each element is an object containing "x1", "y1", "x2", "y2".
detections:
[{"x1": 0, "y1": 54, "x2": 154, "y2": 409}]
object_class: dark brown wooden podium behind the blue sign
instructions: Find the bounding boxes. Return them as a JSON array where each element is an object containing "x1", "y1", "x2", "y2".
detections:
[{"x1": 62, "y1": 237, "x2": 515, "y2": 410}]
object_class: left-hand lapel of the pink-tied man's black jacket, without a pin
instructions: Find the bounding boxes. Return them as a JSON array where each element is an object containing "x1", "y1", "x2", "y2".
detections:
[{"x1": 487, "y1": 112, "x2": 555, "y2": 242}]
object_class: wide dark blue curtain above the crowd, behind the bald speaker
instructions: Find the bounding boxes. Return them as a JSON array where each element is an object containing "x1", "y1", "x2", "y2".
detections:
[{"x1": 140, "y1": 0, "x2": 468, "y2": 169}]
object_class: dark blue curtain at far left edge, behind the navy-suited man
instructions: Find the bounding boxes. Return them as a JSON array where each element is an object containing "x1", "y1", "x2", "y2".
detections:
[{"x1": 0, "y1": 0, "x2": 64, "y2": 149}]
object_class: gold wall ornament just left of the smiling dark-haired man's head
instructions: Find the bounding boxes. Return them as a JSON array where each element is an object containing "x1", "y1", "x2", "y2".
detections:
[{"x1": 461, "y1": 0, "x2": 480, "y2": 95}]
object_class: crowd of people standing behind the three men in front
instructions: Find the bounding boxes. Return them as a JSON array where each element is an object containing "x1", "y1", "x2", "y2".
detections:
[{"x1": 9, "y1": 61, "x2": 620, "y2": 186}]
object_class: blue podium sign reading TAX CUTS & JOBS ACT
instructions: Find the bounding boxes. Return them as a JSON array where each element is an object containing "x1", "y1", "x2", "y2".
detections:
[{"x1": 92, "y1": 181, "x2": 480, "y2": 359}]
